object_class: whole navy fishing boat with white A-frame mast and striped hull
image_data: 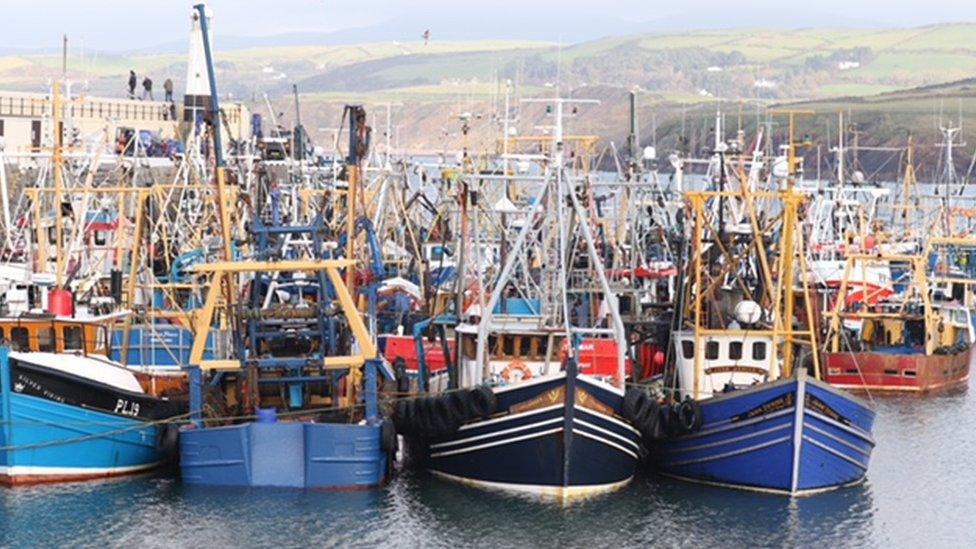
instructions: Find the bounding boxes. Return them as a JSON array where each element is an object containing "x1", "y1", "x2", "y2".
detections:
[{"x1": 394, "y1": 98, "x2": 642, "y2": 500}]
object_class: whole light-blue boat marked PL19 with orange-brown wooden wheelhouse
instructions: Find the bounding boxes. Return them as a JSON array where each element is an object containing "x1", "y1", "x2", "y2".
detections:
[{"x1": 0, "y1": 315, "x2": 186, "y2": 485}]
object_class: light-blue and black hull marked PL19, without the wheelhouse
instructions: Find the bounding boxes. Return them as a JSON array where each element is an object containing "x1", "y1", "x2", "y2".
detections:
[{"x1": 0, "y1": 348, "x2": 176, "y2": 485}]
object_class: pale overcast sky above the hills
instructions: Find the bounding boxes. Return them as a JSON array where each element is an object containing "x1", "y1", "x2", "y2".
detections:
[{"x1": 0, "y1": 0, "x2": 976, "y2": 51}]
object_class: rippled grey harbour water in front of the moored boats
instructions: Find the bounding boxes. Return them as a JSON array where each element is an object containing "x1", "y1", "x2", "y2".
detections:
[{"x1": 0, "y1": 384, "x2": 976, "y2": 548}]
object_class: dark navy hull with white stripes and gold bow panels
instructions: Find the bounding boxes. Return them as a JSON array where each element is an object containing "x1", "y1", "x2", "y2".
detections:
[{"x1": 407, "y1": 374, "x2": 641, "y2": 499}]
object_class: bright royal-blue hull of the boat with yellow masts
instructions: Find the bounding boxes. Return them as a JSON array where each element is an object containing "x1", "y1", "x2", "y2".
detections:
[{"x1": 652, "y1": 372, "x2": 874, "y2": 495}]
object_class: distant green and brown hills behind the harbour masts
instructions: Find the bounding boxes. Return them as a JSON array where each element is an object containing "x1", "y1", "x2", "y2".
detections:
[{"x1": 0, "y1": 24, "x2": 976, "y2": 177}]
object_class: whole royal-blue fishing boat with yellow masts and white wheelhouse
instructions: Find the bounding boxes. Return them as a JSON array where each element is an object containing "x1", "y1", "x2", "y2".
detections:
[{"x1": 651, "y1": 115, "x2": 875, "y2": 496}]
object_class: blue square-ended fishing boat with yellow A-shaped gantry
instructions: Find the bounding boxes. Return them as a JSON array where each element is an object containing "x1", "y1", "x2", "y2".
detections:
[{"x1": 179, "y1": 23, "x2": 396, "y2": 490}]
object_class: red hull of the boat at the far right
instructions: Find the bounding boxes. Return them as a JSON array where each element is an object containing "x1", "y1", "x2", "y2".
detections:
[{"x1": 825, "y1": 346, "x2": 974, "y2": 393}]
